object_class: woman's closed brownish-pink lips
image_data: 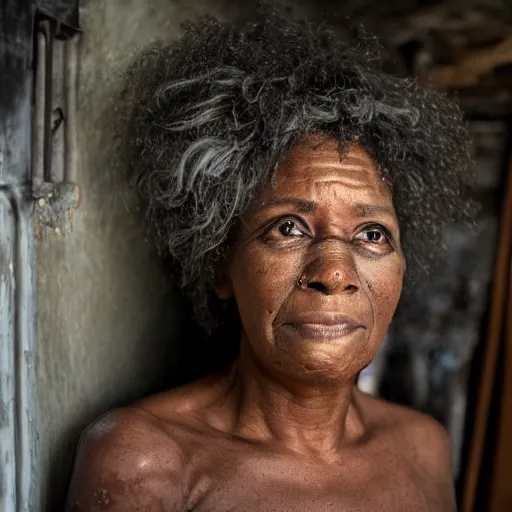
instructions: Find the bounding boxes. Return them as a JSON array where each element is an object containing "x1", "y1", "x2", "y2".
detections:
[{"x1": 283, "y1": 313, "x2": 366, "y2": 340}]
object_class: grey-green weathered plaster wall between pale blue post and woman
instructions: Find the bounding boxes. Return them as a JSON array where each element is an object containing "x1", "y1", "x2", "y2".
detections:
[{"x1": 37, "y1": 0, "x2": 244, "y2": 512}]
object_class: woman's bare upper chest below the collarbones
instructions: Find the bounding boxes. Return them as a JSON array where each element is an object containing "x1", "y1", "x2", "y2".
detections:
[{"x1": 187, "y1": 442, "x2": 443, "y2": 512}]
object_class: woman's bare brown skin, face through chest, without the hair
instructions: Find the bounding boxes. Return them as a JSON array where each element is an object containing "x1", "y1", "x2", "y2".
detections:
[{"x1": 68, "y1": 137, "x2": 455, "y2": 512}]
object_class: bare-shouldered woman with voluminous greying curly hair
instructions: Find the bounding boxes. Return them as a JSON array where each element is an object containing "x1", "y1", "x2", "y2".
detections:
[{"x1": 68, "y1": 8, "x2": 471, "y2": 512}]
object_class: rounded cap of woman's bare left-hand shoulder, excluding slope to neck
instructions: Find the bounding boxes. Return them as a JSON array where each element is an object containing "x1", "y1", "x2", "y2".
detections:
[{"x1": 66, "y1": 407, "x2": 189, "y2": 512}]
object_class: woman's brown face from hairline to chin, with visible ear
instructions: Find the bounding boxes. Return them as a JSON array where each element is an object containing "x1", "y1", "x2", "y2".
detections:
[{"x1": 218, "y1": 137, "x2": 405, "y2": 380}]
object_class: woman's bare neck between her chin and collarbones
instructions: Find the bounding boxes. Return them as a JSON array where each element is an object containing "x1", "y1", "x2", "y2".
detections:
[{"x1": 224, "y1": 346, "x2": 366, "y2": 459}]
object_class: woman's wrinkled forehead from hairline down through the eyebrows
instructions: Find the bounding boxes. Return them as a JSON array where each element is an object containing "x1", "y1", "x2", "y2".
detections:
[{"x1": 244, "y1": 138, "x2": 396, "y2": 227}]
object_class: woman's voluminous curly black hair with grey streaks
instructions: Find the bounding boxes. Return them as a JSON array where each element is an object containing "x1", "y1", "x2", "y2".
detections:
[{"x1": 131, "y1": 10, "x2": 473, "y2": 332}]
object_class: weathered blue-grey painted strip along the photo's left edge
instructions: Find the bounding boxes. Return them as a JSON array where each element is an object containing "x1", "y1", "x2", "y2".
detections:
[{"x1": 0, "y1": 0, "x2": 36, "y2": 512}]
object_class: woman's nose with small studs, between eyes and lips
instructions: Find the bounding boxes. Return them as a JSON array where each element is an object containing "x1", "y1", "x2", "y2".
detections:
[{"x1": 297, "y1": 243, "x2": 360, "y2": 295}]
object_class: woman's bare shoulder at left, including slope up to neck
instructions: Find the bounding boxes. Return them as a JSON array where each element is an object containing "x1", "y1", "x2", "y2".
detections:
[{"x1": 67, "y1": 375, "x2": 230, "y2": 512}]
